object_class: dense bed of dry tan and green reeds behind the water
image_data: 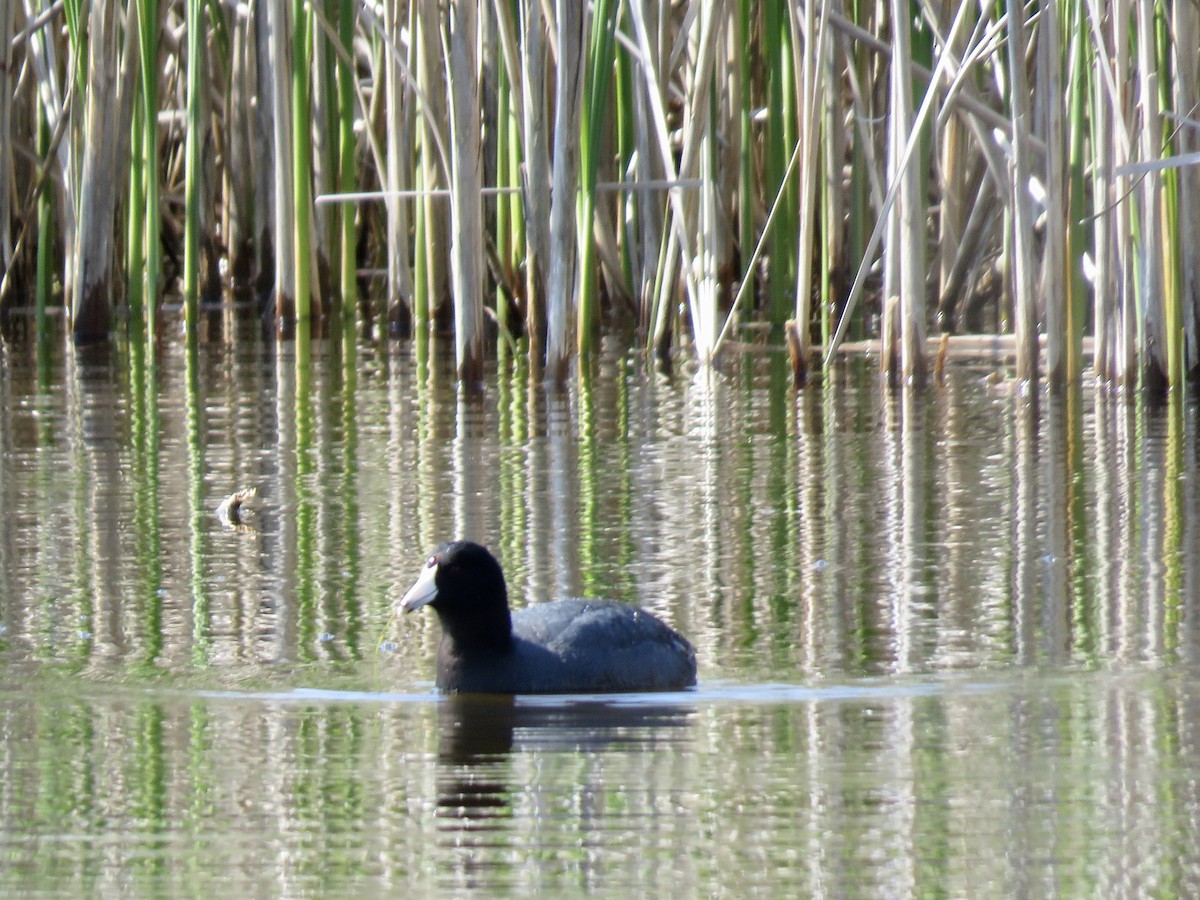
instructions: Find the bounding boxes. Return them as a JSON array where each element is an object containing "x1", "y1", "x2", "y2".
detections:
[{"x1": 0, "y1": 0, "x2": 1200, "y2": 390}]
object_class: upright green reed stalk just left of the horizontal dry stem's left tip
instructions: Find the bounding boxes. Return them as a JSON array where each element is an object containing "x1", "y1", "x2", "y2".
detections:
[{"x1": 289, "y1": 0, "x2": 313, "y2": 331}]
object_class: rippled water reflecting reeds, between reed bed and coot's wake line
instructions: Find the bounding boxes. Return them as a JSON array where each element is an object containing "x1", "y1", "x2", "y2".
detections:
[{"x1": 0, "y1": 343, "x2": 1200, "y2": 680}]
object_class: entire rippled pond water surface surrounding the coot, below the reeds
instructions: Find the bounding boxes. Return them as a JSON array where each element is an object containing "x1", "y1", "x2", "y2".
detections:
[{"x1": 0, "y1": 330, "x2": 1200, "y2": 896}]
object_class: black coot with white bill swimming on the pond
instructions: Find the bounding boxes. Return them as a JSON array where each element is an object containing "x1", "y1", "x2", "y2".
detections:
[{"x1": 400, "y1": 541, "x2": 696, "y2": 694}]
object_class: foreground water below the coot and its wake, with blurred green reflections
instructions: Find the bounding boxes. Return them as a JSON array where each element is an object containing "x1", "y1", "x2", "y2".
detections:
[{"x1": 0, "y1": 673, "x2": 1200, "y2": 896}]
